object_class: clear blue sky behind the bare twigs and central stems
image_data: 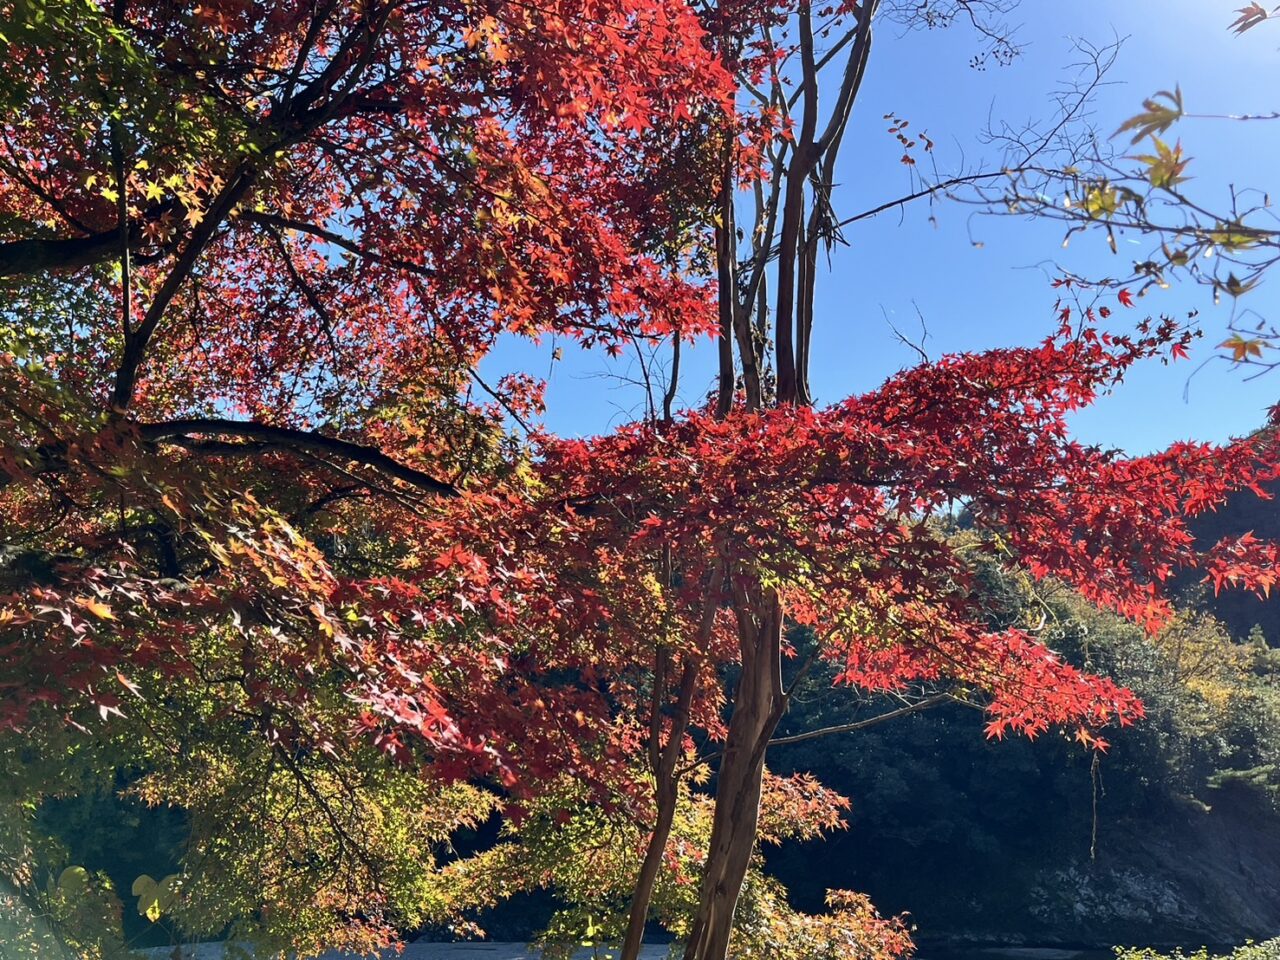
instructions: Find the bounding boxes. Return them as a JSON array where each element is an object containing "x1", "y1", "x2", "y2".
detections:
[{"x1": 484, "y1": 0, "x2": 1280, "y2": 453}]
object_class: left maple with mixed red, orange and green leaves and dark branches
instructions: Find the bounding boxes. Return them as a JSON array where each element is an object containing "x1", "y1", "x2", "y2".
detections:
[{"x1": 0, "y1": 0, "x2": 727, "y2": 952}]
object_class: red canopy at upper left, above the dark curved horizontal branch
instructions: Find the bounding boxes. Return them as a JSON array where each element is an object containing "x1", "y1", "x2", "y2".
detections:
[{"x1": 0, "y1": 0, "x2": 732, "y2": 420}]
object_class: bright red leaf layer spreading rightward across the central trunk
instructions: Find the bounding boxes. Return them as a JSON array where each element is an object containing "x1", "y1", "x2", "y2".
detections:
[{"x1": 330, "y1": 320, "x2": 1276, "y2": 783}]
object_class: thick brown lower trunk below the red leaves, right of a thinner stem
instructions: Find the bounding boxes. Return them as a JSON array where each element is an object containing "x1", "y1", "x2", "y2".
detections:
[{"x1": 685, "y1": 589, "x2": 786, "y2": 960}]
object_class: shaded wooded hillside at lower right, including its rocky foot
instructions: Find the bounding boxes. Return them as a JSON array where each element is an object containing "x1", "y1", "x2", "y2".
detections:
[{"x1": 765, "y1": 519, "x2": 1280, "y2": 956}]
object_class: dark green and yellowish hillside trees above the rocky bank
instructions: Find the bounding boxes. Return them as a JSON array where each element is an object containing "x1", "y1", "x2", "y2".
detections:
[{"x1": 769, "y1": 545, "x2": 1280, "y2": 942}]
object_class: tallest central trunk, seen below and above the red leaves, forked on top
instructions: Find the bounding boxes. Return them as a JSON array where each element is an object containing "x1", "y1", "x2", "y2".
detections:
[{"x1": 685, "y1": 0, "x2": 878, "y2": 960}]
